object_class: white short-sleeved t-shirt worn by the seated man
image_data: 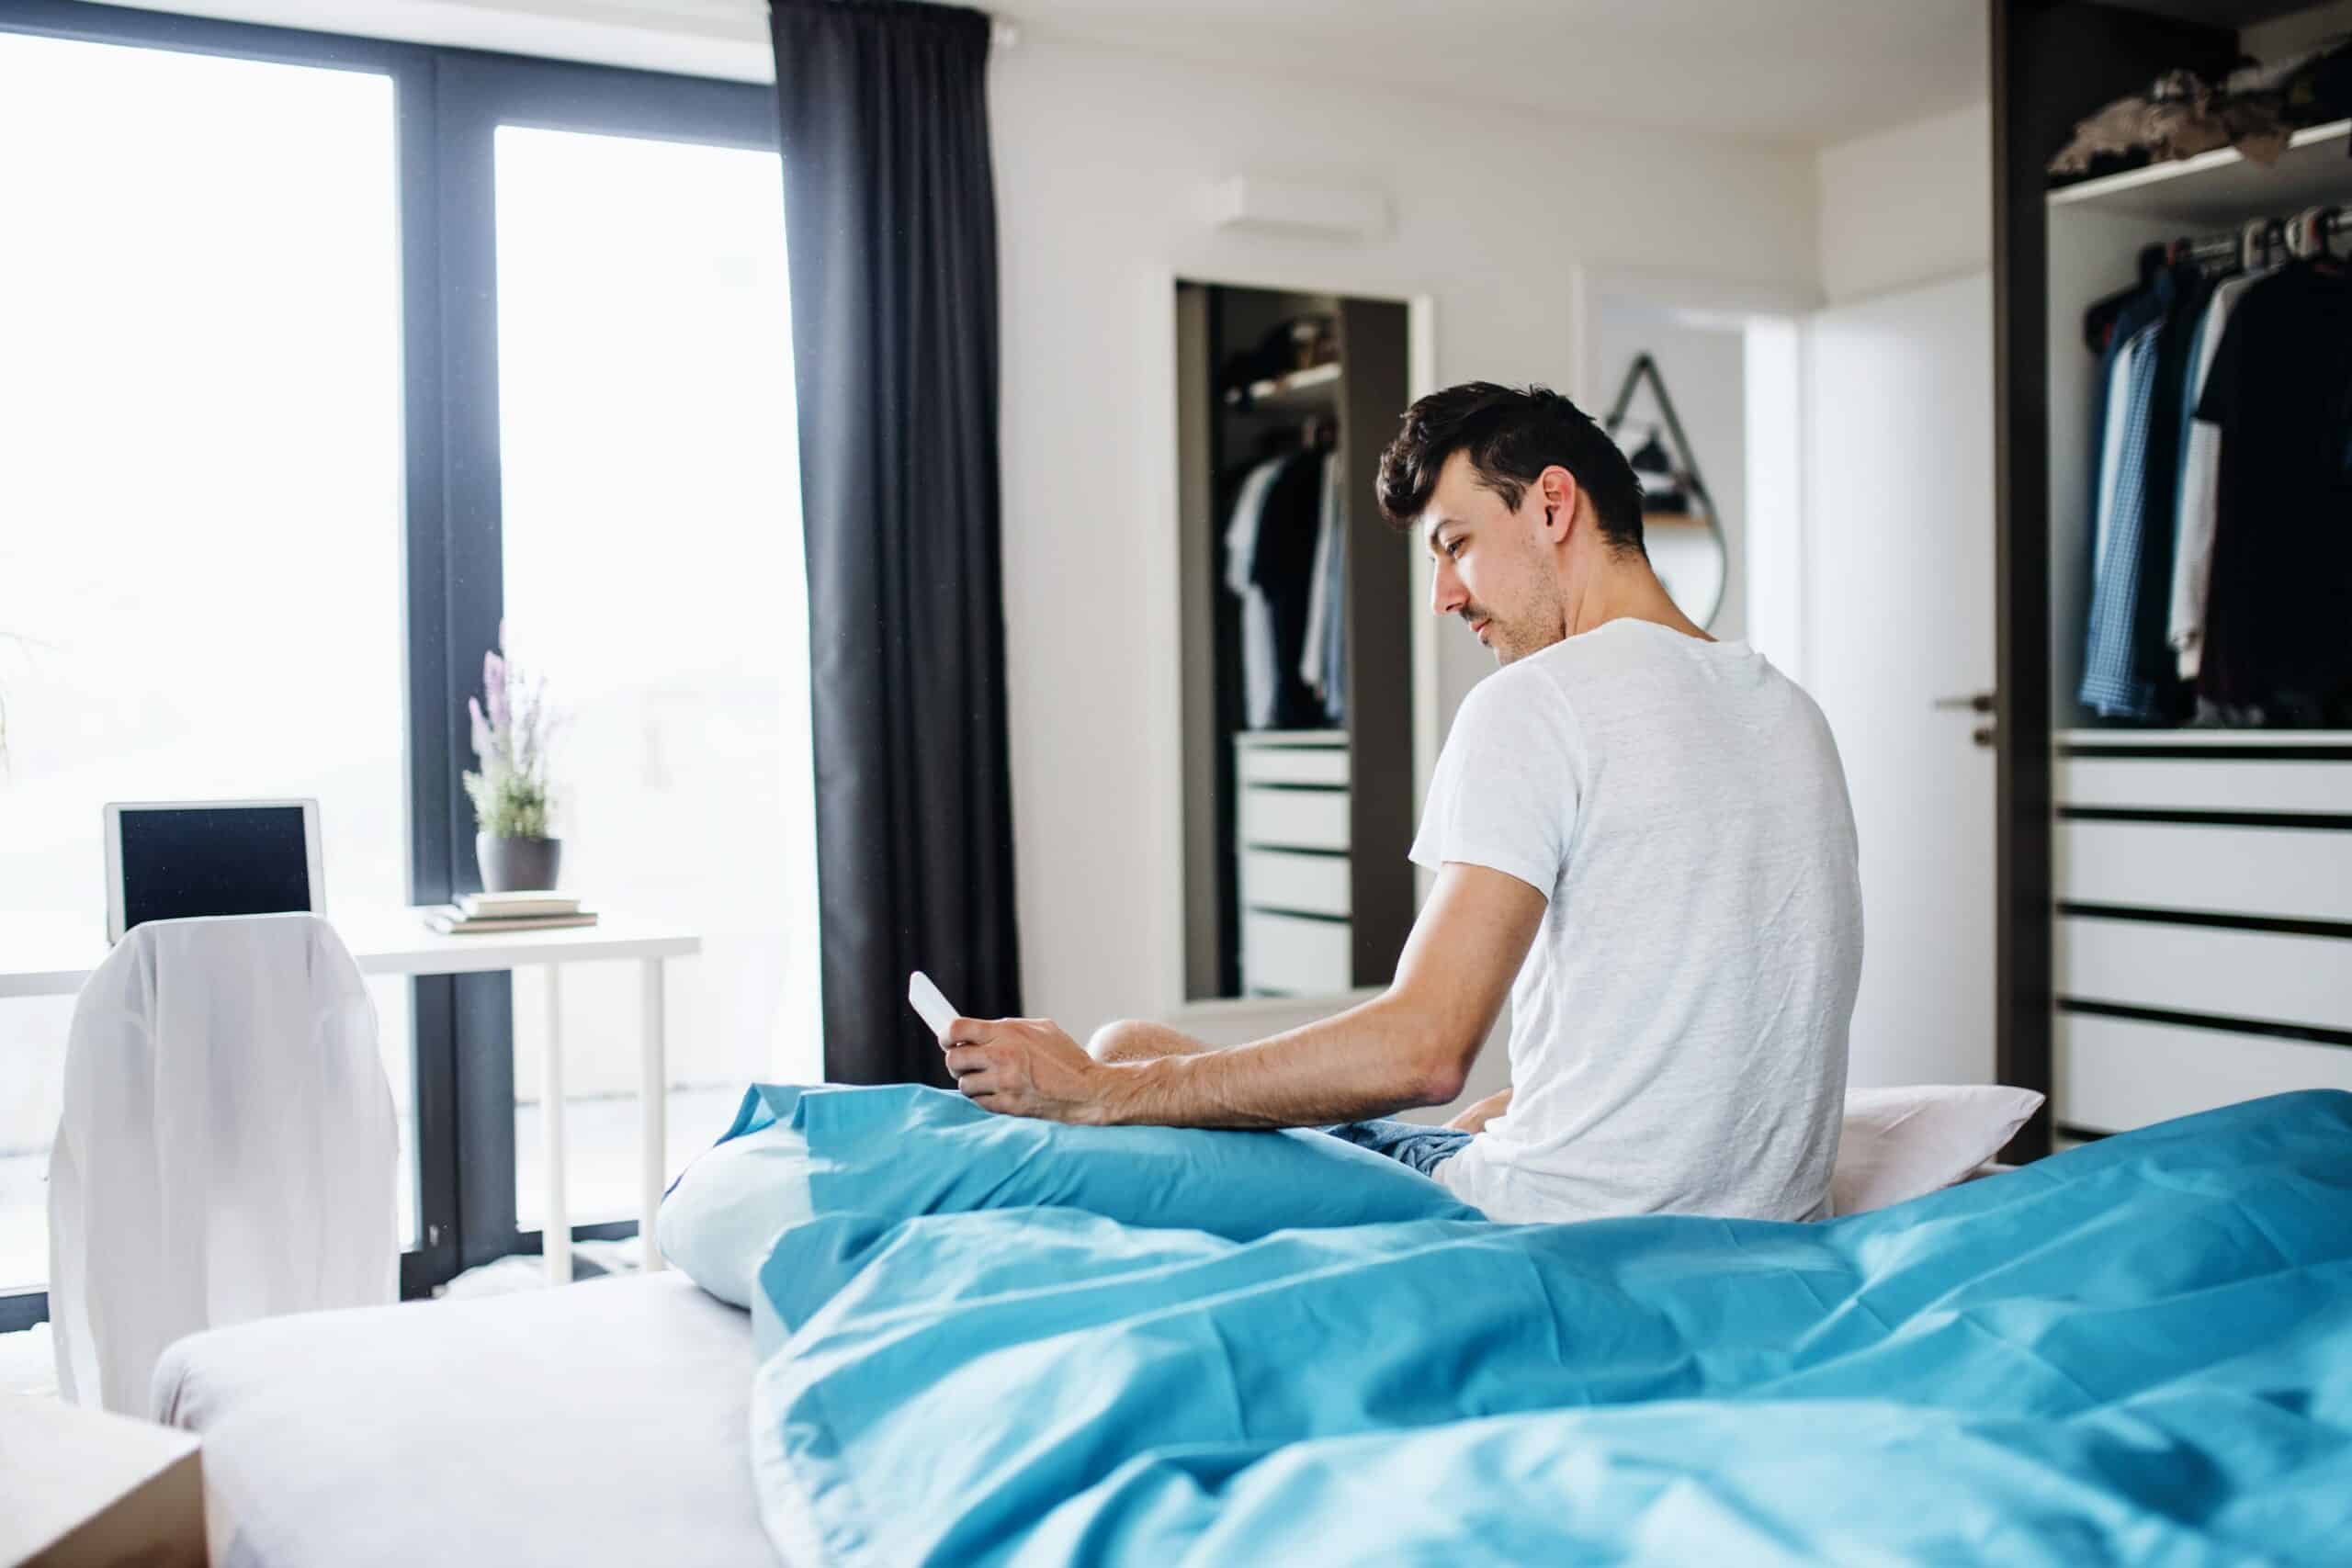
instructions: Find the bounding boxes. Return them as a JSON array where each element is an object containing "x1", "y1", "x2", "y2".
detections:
[{"x1": 1414, "y1": 621, "x2": 1863, "y2": 1220}]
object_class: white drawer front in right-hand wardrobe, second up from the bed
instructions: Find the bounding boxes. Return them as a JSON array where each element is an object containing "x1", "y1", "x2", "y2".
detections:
[{"x1": 2055, "y1": 915, "x2": 2352, "y2": 1030}]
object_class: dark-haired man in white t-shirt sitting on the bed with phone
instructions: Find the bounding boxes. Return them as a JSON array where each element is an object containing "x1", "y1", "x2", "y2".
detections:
[{"x1": 941, "y1": 383, "x2": 1863, "y2": 1220}]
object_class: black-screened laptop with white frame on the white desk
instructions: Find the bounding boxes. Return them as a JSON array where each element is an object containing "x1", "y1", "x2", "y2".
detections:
[{"x1": 106, "y1": 799, "x2": 327, "y2": 945}]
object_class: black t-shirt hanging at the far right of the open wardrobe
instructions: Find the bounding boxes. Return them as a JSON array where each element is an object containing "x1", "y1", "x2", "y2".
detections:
[{"x1": 2197, "y1": 261, "x2": 2352, "y2": 724}]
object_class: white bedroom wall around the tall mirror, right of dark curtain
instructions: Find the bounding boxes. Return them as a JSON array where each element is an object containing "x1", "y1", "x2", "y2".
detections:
[{"x1": 990, "y1": 38, "x2": 1815, "y2": 1053}]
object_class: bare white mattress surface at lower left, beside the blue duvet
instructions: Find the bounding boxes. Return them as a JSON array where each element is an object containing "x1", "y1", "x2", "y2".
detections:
[{"x1": 155, "y1": 1272, "x2": 778, "y2": 1568}]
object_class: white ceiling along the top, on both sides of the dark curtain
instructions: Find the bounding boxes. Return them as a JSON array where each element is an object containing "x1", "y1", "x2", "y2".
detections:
[{"x1": 106, "y1": 0, "x2": 1984, "y2": 146}]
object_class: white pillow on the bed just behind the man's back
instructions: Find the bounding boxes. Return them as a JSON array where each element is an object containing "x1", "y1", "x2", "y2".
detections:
[{"x1": 1830, "y1": 1084, "x2": 2041, "y2": 1213}]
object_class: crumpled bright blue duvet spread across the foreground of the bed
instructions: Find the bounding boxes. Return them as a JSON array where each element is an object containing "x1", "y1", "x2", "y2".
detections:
[{"x1": 710, "y1": 1093, "x2": 2352, "y2": 1568}]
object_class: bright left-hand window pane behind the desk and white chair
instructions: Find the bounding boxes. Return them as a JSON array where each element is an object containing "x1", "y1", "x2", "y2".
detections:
[{"x1": 0, "y1": 33, "x2": 416, "y2": 1286}]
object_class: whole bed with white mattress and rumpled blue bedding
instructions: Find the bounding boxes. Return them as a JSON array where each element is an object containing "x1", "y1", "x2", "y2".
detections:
[{"x1": 158, "y1": 1089, "x2": 2352, "y2": 1568}]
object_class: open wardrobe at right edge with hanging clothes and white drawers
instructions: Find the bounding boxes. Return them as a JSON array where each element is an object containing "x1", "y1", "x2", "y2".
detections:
[{"x1": 1992, "y1": 0, "x2": 2352, "y2": 1156}]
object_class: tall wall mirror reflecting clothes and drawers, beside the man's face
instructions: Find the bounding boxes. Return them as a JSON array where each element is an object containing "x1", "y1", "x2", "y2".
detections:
[{"x1": 1173, "y1": 280, "x2": 1416, "y2": 1001}]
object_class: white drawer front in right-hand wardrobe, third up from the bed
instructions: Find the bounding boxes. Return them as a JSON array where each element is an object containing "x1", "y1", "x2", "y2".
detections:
[{"x1": 2053, "y1": 818, "x2": 2352, "y2": 921}]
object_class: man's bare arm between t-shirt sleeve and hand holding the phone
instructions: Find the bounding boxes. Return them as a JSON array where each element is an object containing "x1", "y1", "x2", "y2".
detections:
[{"x1": 1087, "y1": 863, "x2": 1545, "y2": 1126}]
